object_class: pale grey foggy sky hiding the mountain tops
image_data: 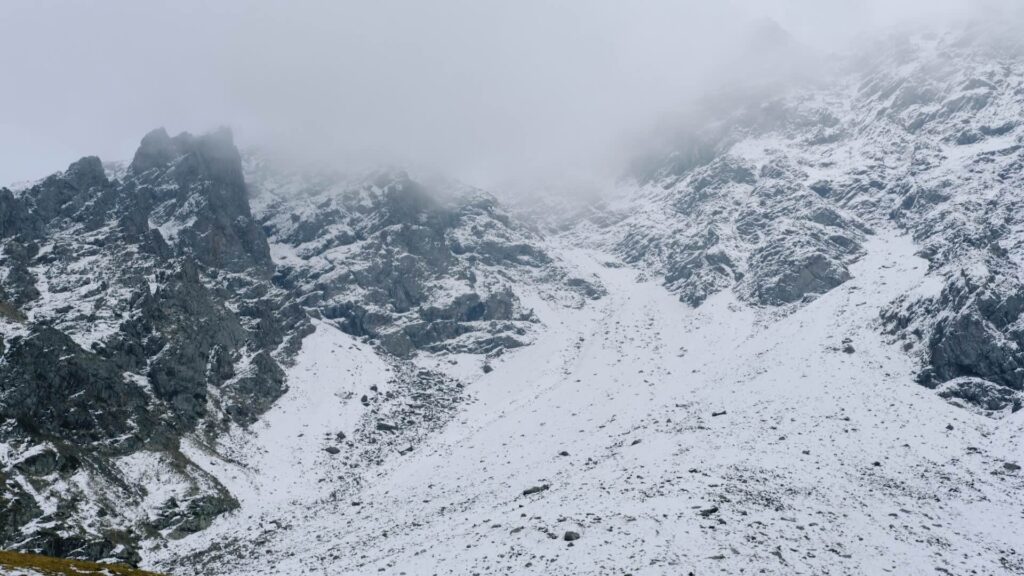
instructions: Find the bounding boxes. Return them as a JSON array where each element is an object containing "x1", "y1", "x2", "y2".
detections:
[{"x1": 0, "y1": 0, "x2": 1007, "y2": 182}]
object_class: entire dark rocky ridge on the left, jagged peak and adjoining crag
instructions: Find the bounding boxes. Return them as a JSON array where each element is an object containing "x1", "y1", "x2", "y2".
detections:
[{"x1": 0, "y1": 129, "x2": 598, "y2": 563}]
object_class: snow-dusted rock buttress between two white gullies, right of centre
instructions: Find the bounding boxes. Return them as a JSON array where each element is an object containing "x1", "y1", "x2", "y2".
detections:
[{"x1": 614, "y1": 136, "x2": 869, "y2": 305}]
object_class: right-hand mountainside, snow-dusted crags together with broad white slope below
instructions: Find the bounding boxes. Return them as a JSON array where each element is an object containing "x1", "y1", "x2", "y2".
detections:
[{"x1": 138, "y1": 23, "x2": 1024, "y2": 574}]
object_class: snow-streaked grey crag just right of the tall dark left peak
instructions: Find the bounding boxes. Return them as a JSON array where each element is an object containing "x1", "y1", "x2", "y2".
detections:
[{"x1": 249, "y1": 158, "x2": 601, "y2": 358}]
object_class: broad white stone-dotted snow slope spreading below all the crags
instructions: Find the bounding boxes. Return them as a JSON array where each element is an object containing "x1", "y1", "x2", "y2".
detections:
[{"x1": 146, "y1": 229, "x2": 1024, "y2": 575}]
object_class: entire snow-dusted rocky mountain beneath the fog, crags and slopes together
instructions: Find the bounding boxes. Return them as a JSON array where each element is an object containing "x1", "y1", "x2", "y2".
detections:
[{"x1": 0, "y1": 21, "x2": 1024, "y2": 575}]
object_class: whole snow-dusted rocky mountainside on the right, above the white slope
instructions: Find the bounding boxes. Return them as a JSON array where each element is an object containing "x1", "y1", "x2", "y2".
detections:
[{"x1": 573, "y1": 29, "x2": 1024, "y2": 416}]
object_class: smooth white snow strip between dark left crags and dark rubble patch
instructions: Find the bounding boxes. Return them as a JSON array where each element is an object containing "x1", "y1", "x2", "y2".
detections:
[{"x1": 176, "y1": 323, "x2": 389, "y2": 512}]
